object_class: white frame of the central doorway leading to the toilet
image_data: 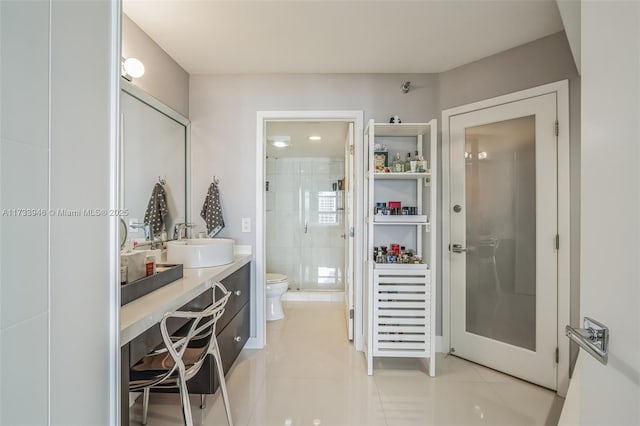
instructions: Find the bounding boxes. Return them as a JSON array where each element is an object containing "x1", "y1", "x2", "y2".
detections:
[{"x1": 255, "y1": 110, "x2": 364, "y2": 351}]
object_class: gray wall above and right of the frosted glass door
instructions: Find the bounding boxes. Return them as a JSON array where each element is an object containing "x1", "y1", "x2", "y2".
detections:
[{"x1": 438, "y1": 32, "x2": 580, "y2": 344}]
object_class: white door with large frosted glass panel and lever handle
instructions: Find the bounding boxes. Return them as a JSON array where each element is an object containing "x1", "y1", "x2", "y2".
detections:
[{"x1": 449, "y1": 93, "x2": 558, "y2": 389}]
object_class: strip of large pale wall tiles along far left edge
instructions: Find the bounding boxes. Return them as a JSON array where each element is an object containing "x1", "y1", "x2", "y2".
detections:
[{"x1": 0, "y1": 1, "x2": 50, "y2": 425}]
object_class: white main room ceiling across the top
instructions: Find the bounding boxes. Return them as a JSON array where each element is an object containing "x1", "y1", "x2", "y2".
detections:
[{"x1": 123, "y1": 0, "x2": 563, "y2": 75}]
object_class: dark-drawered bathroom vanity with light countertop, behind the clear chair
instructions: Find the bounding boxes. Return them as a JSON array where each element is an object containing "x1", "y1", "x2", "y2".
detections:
[{"x1": 120, "y1": 254, "x2": 251, "y2": 425}]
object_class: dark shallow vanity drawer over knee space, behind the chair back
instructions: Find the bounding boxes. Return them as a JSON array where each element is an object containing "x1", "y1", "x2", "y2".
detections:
[{"x1": 123, "y1": 291, "x2": 213, "y2": 366}]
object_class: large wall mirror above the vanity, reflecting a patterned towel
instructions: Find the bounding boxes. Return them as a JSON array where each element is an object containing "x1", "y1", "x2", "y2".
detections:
[{"x1": 120, "y1": 80, "x2": 190, "y2": 240}]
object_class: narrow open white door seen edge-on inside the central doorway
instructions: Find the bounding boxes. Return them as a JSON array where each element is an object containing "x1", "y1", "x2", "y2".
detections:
[{"x1": 344, "y1": 123, "x2": 355, "y2": 340}]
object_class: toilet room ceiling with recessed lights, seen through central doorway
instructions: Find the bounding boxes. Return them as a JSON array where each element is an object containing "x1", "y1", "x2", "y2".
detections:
[{"x1": 266, "y1": 121, "x2": 349, "y2": 159}]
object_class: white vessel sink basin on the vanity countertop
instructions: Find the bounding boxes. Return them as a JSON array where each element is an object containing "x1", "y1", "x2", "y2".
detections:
[{"x1": 167, "y1": 238, "x2": 234, "y2": 268}]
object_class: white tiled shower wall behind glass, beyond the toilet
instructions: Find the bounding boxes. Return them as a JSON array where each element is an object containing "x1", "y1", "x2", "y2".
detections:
[{"x1": 265, "y1": 158, "x2": 345, "y2": 290}]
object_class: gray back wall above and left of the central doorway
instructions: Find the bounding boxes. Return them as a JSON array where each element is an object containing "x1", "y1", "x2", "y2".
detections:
[{"x1": 189, "y1": 74, "x2": 439, "y2": 340}]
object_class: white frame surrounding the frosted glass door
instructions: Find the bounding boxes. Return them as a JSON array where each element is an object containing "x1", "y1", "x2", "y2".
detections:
[{"x1": 441, "y1": 80, "x2": 571, "y2": 396}]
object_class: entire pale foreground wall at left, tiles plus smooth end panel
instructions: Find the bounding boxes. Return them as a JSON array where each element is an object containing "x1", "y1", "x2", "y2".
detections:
[{"x1": 0, "y1": 0, "x2": 119, "y2": 425}]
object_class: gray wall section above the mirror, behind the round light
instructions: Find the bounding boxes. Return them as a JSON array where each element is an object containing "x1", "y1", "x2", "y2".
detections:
[{"x1": 122, "y1": 13, "x2": 189, "y2": 117}]
